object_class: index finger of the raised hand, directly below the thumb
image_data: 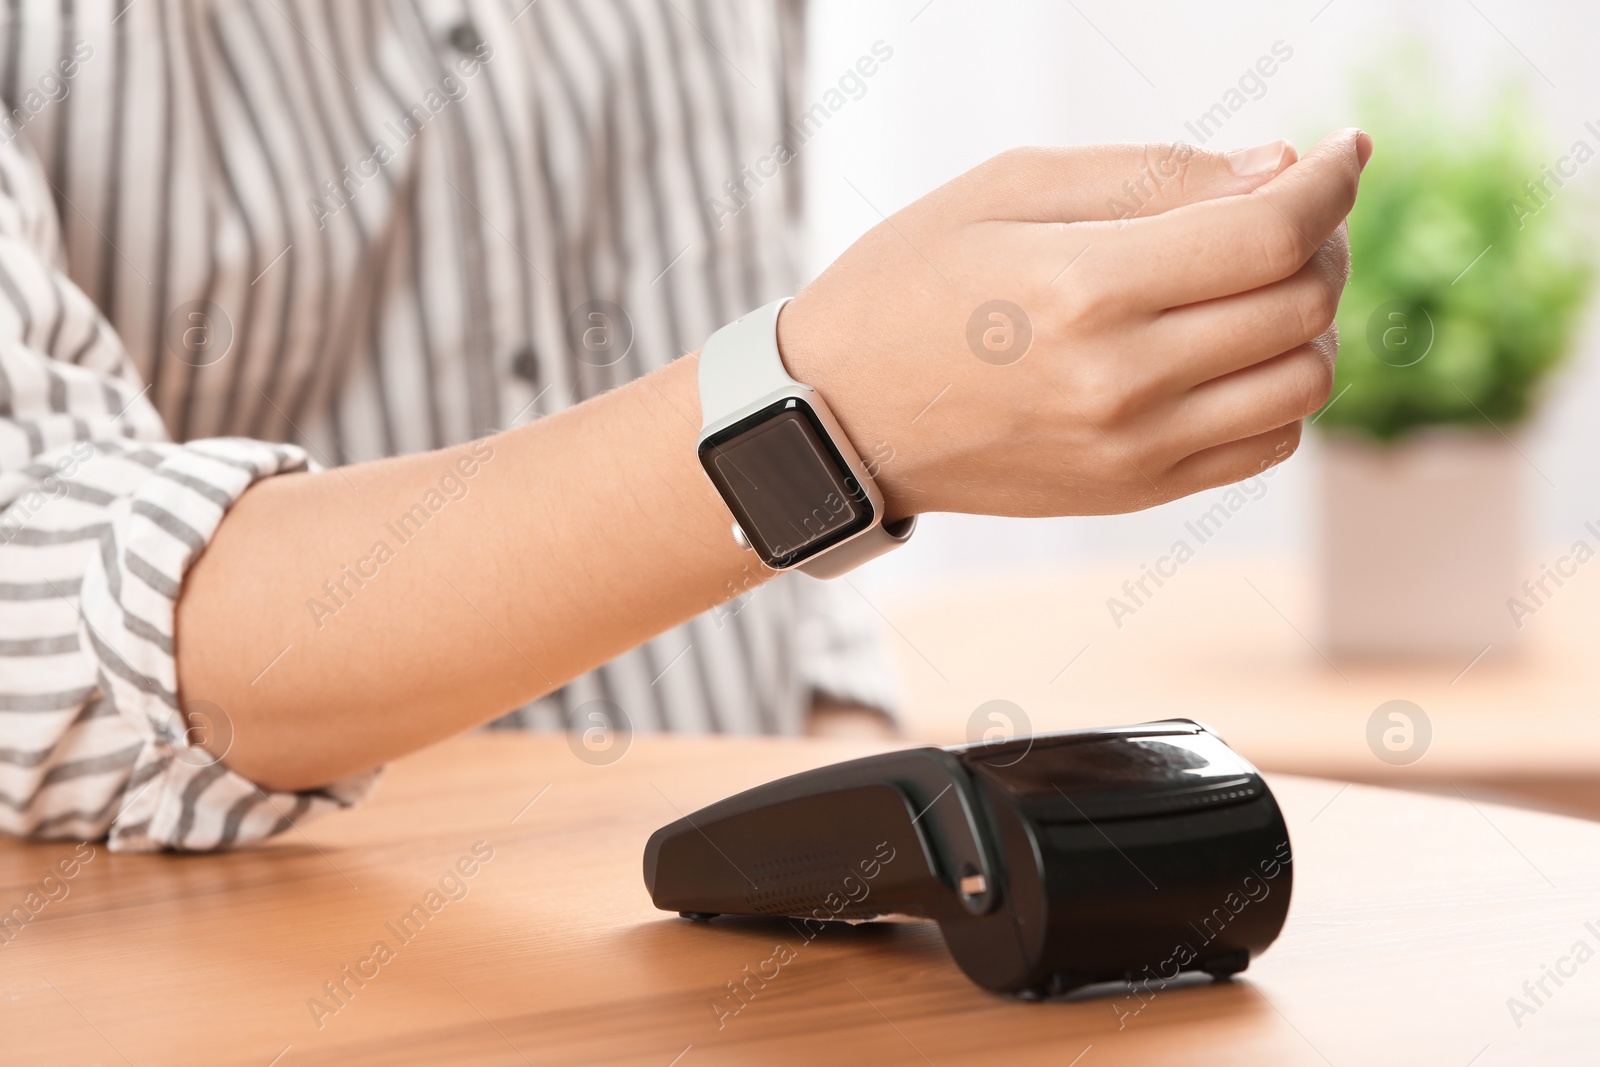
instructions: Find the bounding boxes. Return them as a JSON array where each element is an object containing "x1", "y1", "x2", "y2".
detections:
[{"x1": 1064, "y1": 130, "x2": 1370, "y2": 310}]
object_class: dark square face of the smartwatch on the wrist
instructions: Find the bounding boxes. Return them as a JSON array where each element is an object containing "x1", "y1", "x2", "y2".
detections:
[{"x1": 699, "y1": 397, "x2": 874, "y2": 568}]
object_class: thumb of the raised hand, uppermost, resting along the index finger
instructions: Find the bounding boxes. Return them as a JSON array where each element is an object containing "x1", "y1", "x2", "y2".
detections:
[{"x1": 952, "y1": 141, "x2": 1299, "y2": 222}]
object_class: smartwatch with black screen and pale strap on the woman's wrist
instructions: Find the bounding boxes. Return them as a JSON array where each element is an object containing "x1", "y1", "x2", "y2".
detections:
[{"x1": 696, "y1": 298, "x2": 917, "y2": 577}]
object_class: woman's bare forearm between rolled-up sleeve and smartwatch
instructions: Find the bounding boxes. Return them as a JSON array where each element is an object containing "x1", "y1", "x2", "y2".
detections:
[{"x1": 178, "y1": 357, "x2": 748, "y2": 789}]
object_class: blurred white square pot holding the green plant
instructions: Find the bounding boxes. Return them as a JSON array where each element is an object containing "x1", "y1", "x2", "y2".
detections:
[{"x1": 1320, "y1": 429, "x2": 1526, "y2": 664}]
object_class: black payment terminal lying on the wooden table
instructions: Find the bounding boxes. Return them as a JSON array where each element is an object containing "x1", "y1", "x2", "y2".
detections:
[{"x1": 645, "y1": 720, "x2": 1293, "y2": 997}]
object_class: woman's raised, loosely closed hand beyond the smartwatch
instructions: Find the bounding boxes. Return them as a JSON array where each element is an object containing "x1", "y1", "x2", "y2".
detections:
[{"x1": 778, "y1": 130, "x2": 1371, "y2": 518}]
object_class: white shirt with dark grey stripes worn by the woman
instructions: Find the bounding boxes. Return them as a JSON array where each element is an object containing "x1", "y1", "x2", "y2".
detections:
[{"x1": 0, "y1": 0, "x2": 893, "y2": 849}]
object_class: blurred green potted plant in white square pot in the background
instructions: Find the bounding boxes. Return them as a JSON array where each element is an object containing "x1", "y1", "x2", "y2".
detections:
[{"x1": 1315, "y1": 77, "x2": 1600, "y2": 657}]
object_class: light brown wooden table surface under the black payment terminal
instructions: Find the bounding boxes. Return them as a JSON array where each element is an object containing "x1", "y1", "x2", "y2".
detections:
[{"x1": 0, "y1": 733, "x2": 1600, "y2": 1067}]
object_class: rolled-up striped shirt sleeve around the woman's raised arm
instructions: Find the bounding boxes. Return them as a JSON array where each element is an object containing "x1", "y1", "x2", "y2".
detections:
[{"x1": 0, "y1": 133, "x2": 374, "y2": 851}]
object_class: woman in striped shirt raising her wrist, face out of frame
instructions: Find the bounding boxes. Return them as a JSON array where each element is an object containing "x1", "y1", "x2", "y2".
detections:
[{"x1": 0, "y1": 0, "x2": 1370, "y2": 849}]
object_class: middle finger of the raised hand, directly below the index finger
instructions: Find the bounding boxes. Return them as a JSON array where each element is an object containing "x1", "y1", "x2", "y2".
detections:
[{"x1": 1147, "y1": 222, "x2": 1350, "y2": 389}]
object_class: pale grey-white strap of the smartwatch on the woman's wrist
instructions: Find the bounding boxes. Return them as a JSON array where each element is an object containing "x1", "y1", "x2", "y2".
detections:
[{"x1": 699, "y1": 296, "x2": 917, "y2": 577}]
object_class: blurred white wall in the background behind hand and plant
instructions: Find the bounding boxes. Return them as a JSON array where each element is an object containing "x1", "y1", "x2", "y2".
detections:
[{"x1": 802, "y1": 0, "x2": 1600, "y2": 589}]
